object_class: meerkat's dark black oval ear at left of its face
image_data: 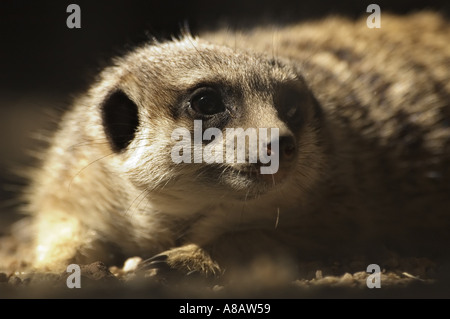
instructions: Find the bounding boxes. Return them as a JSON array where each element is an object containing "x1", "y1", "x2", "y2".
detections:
[{"x1": 101, "y1": 90, "x2": 139, "y2": 153}]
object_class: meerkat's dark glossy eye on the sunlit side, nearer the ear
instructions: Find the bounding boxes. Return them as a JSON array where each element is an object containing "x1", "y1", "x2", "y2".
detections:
[{"x1": 189, "y1": 88, "x2": 226, "y2": 115}]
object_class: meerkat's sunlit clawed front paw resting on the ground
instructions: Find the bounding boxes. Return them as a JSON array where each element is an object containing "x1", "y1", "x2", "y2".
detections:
[{"x1": 139, "y1": 244, "x2": 222, "y2": 278}]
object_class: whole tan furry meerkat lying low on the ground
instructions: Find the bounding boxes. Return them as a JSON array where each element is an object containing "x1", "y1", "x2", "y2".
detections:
[{"x1": 14, "y1": 13, "x2": 450, "y2": 277}]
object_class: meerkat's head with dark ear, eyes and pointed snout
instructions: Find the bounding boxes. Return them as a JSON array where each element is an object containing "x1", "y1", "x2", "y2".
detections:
[{"x1": 96, "y1": 36, "x2": 323, "y2": 212}]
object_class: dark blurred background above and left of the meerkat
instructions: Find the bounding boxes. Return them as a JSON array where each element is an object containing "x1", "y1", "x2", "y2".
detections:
[{"x1": 0, "y1": 0, "x2": 450, "y2": 233}]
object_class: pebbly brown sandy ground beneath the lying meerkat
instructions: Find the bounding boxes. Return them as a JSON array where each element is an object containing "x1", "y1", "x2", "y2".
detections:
[{"x1": 0, "y1": 228, "x2": 450, "y2": 299}]
